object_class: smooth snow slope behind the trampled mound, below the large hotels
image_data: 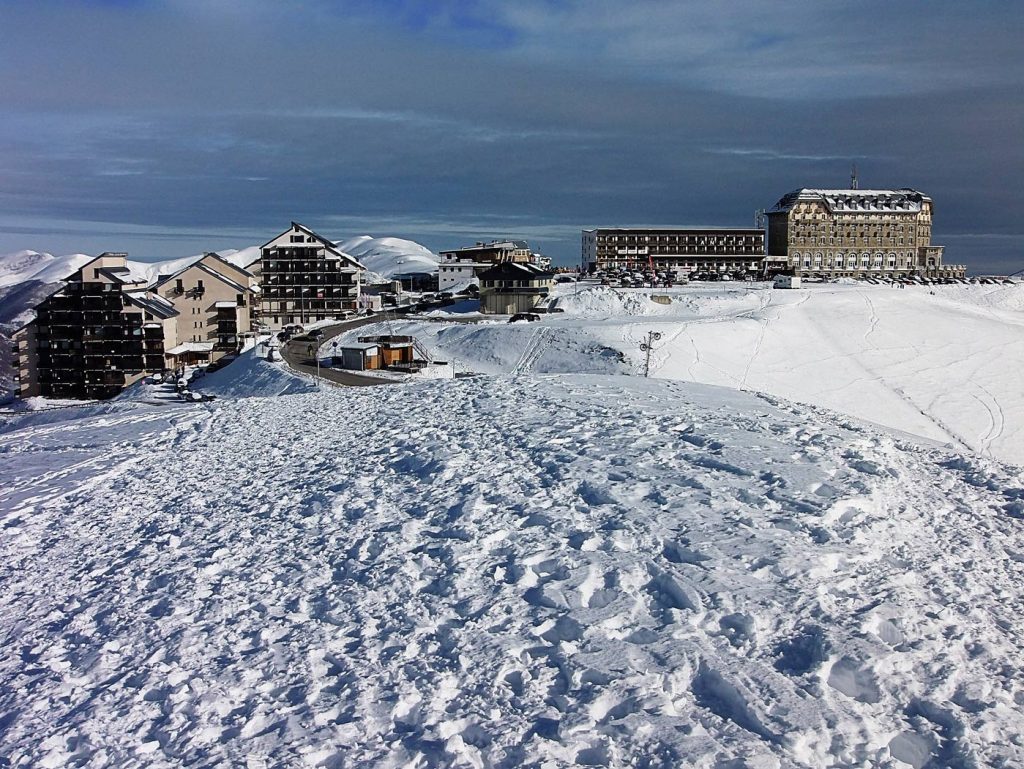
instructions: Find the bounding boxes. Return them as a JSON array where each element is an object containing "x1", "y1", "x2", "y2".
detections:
[{"x1": 348, "y1": 284, "x2": 1024, "y2": 465}]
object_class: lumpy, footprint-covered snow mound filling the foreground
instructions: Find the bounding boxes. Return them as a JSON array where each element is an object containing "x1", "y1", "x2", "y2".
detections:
[{"x1": 0, "y1": 376, "x2": 1024, "y2": 769}]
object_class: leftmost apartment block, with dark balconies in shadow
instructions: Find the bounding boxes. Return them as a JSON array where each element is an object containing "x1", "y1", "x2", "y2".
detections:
[{"x1": 13, "y1": 252, "x2": 178, "y2": 399}]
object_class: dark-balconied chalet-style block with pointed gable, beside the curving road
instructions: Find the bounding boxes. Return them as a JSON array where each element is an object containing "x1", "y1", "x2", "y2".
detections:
[{"x1": 253, "y1": 221, "x2": 366, "y2": 331}]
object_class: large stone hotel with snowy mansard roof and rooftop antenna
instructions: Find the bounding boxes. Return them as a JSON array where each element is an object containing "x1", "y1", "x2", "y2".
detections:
[{"x1": 766, "y1": 187, "x2": 967, "y2": 277}]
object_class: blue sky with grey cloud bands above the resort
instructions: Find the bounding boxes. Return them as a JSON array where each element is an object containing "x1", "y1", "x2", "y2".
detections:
[{"x1": 0, "y1": 0, "x2": 1024, "y2": 271}]
